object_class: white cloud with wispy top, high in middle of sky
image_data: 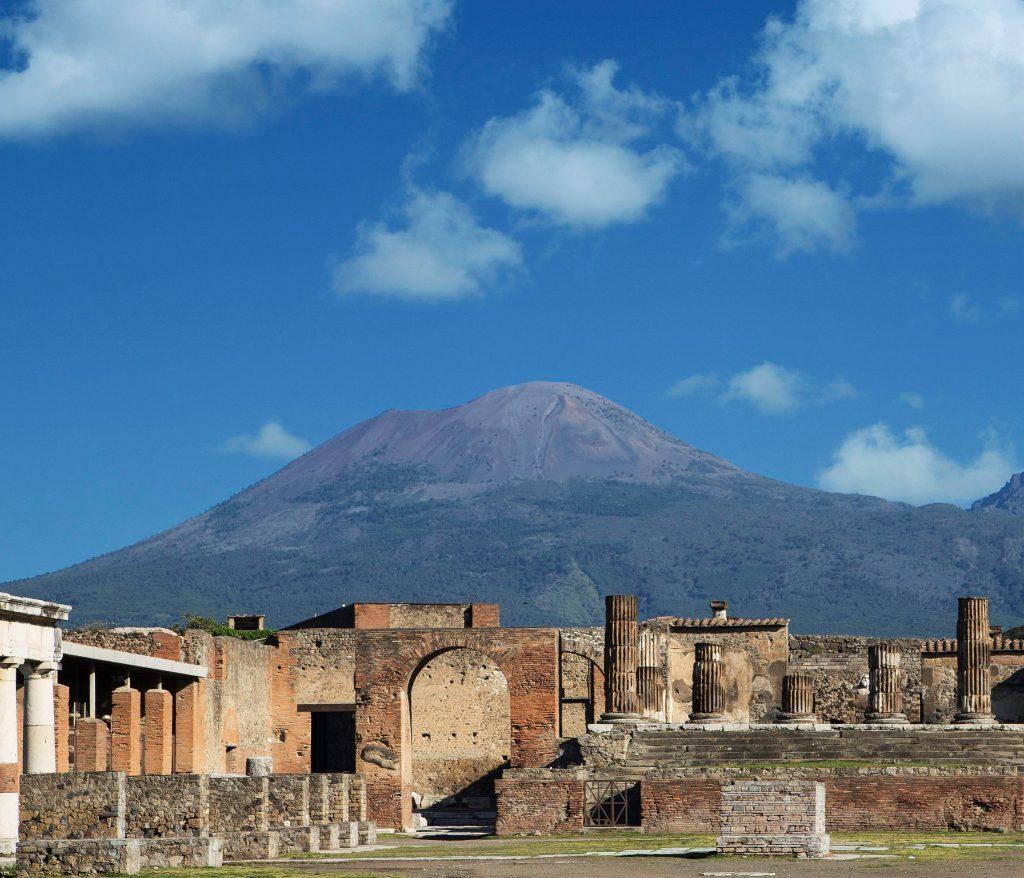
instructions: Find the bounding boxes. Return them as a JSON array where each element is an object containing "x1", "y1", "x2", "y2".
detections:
[{"x1": 465, "y1": 60, "x2": 682, "y2": 228}]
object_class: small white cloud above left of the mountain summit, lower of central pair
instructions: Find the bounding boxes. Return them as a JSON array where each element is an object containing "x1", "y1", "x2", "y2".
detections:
[{"x1": 334, "y1": 189, "x2": 521, "y2": 301}]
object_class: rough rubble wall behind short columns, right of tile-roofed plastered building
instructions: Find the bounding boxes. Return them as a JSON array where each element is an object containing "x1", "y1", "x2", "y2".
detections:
[{"x1": 790, "y1": 634, "x2": 922, "y2": 722}]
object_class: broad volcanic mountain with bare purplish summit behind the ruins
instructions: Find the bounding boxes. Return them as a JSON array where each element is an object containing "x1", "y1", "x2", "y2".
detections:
[{"x1": 3, "y1": 382, "x2": 1024, "y2": 635}]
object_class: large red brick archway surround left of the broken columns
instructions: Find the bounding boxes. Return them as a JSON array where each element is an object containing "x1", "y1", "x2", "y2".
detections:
[{"x1": 355, "y1": 628, "x2": 559, "y2": 829}]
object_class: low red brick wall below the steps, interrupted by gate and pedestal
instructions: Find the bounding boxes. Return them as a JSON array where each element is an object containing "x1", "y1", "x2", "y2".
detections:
[{"x1": 496, "y1": 775, "x2": 1024, "y2": 835}]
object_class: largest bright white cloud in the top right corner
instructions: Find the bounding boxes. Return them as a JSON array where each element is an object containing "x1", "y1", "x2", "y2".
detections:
[{"x1": 682, "y1": 0, "x2": 1024, "y2": 249}]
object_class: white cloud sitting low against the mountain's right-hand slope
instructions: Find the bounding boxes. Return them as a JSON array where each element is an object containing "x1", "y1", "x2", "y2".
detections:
[{"x1": 818, "y1": 423, "x2": 1018, "y2": 505}]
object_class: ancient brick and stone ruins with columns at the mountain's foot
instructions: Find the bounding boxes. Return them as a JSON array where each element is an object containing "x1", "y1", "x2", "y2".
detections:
[{"x1": 6, "y1": 595, "x2": 1024, "y2": 871}]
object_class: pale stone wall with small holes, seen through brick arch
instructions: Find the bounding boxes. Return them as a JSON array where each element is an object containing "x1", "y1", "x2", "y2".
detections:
[{"x1": 410, "y1": 650, "x2": 512, "y2": 805}]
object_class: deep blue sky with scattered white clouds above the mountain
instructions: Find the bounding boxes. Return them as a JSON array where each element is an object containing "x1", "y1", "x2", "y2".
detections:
[{"x1": 0, "y1": 0, "x2": 1024, "y2": 580}]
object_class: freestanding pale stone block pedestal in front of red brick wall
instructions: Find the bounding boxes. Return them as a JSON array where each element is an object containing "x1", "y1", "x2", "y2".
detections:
[{"x1": 715, "y1": 781, "x2": 828, "y2": 856}]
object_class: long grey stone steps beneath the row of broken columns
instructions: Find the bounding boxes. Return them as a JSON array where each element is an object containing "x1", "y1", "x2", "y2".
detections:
[{"x1": 624, "y1": 727, "x2": 1024, "y2": 771}]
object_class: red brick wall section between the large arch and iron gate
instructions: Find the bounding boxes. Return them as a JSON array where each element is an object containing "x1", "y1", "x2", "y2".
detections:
[{"x1": 495, "y1": 778, "x2": 584, "y2": 835}]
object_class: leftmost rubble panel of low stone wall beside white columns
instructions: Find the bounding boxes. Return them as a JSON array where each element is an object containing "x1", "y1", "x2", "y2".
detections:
[{"x1": 19, "y1": 771, "x2": 126, "y2": 840}]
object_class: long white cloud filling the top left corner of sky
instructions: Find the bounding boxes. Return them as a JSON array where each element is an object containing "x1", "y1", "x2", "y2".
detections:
[{"x1": 0, "y1": 0, "x2": 453, "y2": 136}]
